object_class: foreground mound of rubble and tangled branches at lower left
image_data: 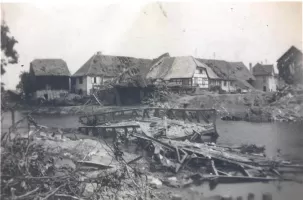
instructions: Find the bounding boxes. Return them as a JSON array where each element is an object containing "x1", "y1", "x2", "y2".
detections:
[{"x1": 1, "y1": 128, "x2": 157, "y2": 199}]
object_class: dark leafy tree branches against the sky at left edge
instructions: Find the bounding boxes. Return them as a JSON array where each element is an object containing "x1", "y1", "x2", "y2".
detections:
[{"x1": 1, "y1": 21, "x2": 19, "y2": 75}]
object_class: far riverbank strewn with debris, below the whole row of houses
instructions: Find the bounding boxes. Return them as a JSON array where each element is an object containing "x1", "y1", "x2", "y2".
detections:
[{"x1": 13, "y1": 84, "x2": 303, "y2": 122}]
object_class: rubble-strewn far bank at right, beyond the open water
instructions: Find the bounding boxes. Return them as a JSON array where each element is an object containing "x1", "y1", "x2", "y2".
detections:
[{"x1": 179, "y1": 89, "x2": 303, "y2": 122}]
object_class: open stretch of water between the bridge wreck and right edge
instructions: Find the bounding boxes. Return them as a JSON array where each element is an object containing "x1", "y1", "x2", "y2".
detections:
[{"x1": 217, "y1": 120, "x2": 303, "y2": 161}]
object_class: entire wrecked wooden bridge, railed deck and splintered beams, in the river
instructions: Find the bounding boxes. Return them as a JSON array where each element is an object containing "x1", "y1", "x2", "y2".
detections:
[{"x1": 79, "y1": 107, "x2": 303, "y2": 183}]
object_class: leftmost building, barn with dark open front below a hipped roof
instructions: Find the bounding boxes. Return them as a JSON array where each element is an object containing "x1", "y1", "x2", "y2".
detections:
[{"x1": 30, "y1": 59, "x2": 70, "y2": 100}]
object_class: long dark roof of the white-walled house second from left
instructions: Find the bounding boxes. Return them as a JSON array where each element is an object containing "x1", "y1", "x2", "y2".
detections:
[{"x1": 73, "y1": 53, "x2": 151, "y2": 77}]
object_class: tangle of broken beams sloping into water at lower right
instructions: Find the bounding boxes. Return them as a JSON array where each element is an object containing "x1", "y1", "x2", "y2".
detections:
[{"x1": 131, "y1": 134, "x2": 303, "y2": 183}]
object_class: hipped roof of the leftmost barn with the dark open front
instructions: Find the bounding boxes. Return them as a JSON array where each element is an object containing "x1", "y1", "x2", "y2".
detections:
[{"x1": 30, "y1": 59, "x2": 70, "y2": 76}]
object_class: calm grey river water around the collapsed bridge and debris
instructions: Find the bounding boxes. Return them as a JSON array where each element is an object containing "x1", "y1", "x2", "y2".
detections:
[{"x1": 2, "y1": 113, "x2": 303, "y2": 200}]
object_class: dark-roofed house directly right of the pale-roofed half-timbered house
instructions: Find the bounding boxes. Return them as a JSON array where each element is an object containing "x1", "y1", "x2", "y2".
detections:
[{"x1": 197, "y1": 58, "x2": 255, "y2": 92}]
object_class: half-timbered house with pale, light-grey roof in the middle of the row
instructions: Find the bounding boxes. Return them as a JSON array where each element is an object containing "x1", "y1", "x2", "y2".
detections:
[{"x1": 147, "y1": 56, "x2": 220, "y2": 89}]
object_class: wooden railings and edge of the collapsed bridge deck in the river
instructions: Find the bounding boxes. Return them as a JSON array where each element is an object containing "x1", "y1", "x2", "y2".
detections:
[{"x1": 79, "y1": 107, "x2": 218, "y2": 140}]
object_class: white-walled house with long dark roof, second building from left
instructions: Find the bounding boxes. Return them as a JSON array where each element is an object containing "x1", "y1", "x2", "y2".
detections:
[{"x1": 71, "y1": 52, "x2": 150, "y2": 95}]
